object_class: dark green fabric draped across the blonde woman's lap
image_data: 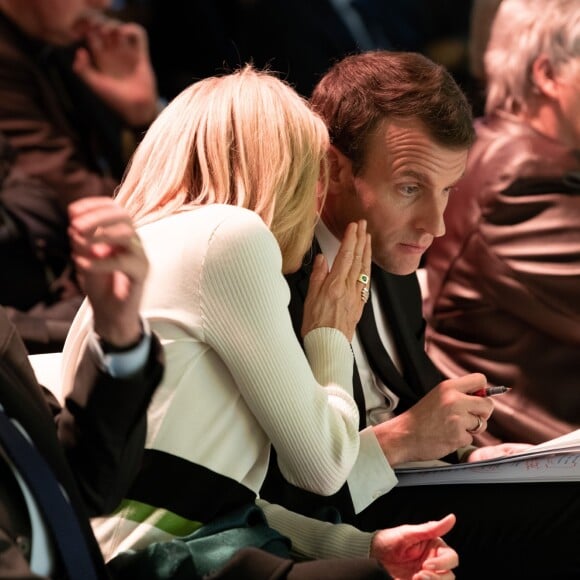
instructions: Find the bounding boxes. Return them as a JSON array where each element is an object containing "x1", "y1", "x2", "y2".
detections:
[{"x1": 108, "y1": 504, "x2": 291, "y2": 580}]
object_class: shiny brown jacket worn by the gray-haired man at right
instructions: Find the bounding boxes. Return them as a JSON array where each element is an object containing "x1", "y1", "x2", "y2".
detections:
[{"x1": 424, "y1": 115, "x2": 580, "y2": 443}]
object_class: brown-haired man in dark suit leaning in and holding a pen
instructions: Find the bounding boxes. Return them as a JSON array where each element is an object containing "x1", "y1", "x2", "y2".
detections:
[{"x1": 261, "y1": 52, "x2": 580, "y2": 580}]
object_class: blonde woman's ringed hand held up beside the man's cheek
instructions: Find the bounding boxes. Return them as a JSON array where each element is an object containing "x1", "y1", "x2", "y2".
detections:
[{"x1": 302, "y1": 220, "x2": 371, "y2": 341}]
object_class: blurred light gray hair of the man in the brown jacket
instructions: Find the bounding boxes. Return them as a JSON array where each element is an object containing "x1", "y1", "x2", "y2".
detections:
[{"x1": 484, "y1": 0, "x2": 580, "y2": 114}]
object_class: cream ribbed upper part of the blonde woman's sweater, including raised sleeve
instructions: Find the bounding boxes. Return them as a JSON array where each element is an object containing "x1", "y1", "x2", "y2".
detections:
[{"x1": 64, "y1": 205, "x2": 368, "y2": 556}]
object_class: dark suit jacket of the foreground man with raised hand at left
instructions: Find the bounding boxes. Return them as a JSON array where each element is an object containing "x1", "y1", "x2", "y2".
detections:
[{"x1": 0, "y1": 307, "x2": 163, "y2": 578}]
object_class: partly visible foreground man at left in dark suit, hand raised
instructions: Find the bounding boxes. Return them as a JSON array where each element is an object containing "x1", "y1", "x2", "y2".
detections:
[{"x1": 0, "y1": 198, "x2": 163, "y2": 578}]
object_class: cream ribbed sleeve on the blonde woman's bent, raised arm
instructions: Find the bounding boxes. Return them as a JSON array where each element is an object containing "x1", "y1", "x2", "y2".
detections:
[{"x1": 201, "y1": 212, "x2": 359, "y2": 495}]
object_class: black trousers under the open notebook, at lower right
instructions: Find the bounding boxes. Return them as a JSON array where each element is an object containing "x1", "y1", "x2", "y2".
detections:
[{"x1": 352, "y1": 482, "x2": 580, "y2": 580}]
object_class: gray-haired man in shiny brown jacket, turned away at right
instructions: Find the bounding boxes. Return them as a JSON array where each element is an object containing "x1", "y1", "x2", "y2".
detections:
[{"x1": 426, "y1": 0, "x2": 580, "y2": 443}]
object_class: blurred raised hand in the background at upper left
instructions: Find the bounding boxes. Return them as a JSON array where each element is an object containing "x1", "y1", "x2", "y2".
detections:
[{"x1": 73, "y1": 14, "x2": 158, "y2": 127}]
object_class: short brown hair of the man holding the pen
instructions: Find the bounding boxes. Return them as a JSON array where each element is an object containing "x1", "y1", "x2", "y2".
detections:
[{"x1": 310, "y1": 50, "x2": 475, "y2": 173}]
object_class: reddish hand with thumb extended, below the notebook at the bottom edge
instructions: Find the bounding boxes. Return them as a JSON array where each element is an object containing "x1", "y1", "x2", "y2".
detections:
[{"x1": 370, "y1": 514, "x2": 459, "y2": 580}]
